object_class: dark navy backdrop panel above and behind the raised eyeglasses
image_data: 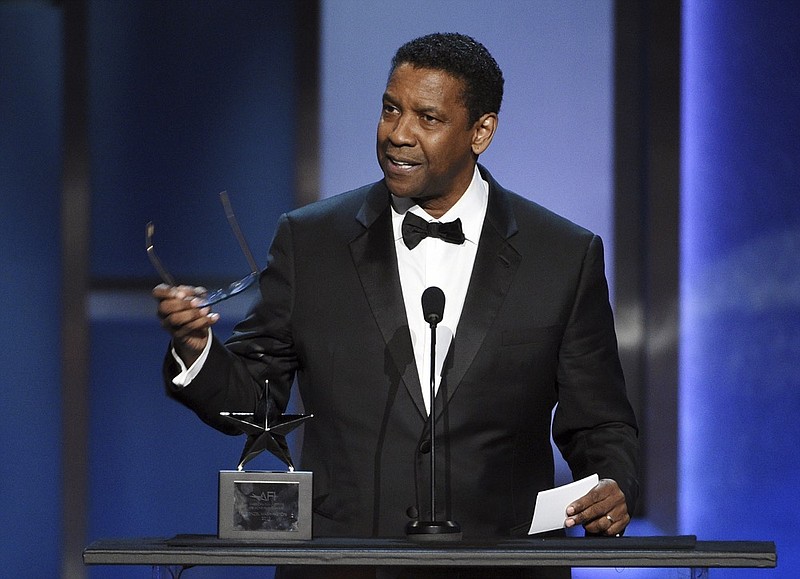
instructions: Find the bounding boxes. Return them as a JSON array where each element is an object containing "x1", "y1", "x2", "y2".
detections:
[{"x1": 89, "y1": 0, "x2": 295, "y2": 283}]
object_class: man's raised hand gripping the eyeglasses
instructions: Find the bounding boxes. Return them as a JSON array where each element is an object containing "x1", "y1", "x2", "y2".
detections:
[{"x1": 153, "y1": 284, "x2": 219, "y2": 367}]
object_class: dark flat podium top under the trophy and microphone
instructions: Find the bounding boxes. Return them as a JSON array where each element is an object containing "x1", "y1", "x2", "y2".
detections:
[{"x1": 83, "y1": 535, "x2": 777, "y2": 579}]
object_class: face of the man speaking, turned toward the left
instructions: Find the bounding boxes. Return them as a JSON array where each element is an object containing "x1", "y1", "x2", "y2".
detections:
[{"x1": 377, "y1": 64, "x2": 482, "y2": 217}]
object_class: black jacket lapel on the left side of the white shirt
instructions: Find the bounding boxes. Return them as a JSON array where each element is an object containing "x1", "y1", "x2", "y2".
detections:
[{"x1": 350, "y1": 182, "x2": 426, "y2": 417}]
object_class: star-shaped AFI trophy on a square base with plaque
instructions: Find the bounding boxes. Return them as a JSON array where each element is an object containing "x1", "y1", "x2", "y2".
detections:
[{"x1": 218, "y1": 382, "x2": 313, "y2": 543}]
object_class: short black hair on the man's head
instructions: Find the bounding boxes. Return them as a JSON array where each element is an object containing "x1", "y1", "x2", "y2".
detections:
[{"x1": 389, "y1": 32, "x2": 503, "y2": 125}]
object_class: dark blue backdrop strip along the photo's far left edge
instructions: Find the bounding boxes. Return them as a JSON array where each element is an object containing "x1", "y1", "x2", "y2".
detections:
[{"x1": 0, "y1": 2, "x2": 64, "y2": 577}]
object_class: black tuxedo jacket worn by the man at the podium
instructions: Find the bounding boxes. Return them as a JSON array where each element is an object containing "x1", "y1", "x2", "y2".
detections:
[{"x1": 166, "y1": 168, "x2": 638, "y2": 537}]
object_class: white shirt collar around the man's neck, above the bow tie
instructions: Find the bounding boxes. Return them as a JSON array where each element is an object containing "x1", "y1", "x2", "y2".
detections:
[{"x1": 392, "y1": 165, "x2": 489, "y2": 245}]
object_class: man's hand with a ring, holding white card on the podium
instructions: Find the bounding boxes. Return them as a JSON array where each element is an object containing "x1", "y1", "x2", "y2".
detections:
[{"x1": 565, "y1": 478, "x2": 631, "y2": 536}]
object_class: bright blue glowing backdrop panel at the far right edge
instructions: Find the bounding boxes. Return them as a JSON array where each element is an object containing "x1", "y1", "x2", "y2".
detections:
[{"x1": 680, "y1": 0, "x2": 800, "y2": 579}]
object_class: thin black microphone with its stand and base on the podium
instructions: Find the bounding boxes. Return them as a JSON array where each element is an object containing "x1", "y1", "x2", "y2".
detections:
[{"x1": 406, "y1": 286, "x2": 462, "y2": 541}]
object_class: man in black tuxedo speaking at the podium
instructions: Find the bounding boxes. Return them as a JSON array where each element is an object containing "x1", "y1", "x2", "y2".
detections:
[{"x1": 153, "y1": 34, "x2": 638, "y2": 577}]
